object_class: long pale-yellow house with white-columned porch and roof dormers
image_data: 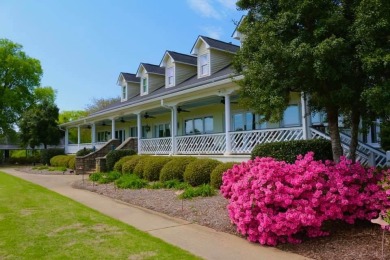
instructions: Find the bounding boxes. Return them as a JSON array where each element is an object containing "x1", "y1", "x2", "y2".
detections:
[{"x1": 61, "y1": 33, "x2": 382, "y2": 167}]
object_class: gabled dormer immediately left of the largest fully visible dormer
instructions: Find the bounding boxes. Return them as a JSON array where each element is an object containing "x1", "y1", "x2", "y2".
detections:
[{"x1": 160, "y1": 51, "x2": 197, "y2": 88}]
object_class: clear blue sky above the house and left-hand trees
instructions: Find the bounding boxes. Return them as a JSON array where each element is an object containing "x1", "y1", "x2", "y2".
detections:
[{"x1": 0, "y1": 0, "x2": 243, "y2": 111}]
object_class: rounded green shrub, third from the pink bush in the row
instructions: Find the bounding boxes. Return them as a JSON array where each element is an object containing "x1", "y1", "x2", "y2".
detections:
[{"x1": 160, "y1": 156, "x2": 196, "y2": 182}]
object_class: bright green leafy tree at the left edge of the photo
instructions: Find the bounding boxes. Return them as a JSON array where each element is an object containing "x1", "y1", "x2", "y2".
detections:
[{"x1": 0, "y1": 39, "x2": 42, "y2": 135}]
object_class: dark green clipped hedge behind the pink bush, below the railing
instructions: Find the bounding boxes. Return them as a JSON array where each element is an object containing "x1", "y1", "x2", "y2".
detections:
[{"x1": 251, "y1": 139, "x2": 333, "y2": 163}]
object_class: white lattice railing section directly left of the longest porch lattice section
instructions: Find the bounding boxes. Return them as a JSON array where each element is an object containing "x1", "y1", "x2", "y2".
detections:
[{"x1": 176, "y1": 134, "x2": 226, "y2": 154}]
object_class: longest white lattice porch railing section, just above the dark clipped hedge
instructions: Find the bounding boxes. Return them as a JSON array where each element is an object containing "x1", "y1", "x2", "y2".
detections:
[{"x1": 230, "y1": 127, "x2": 303, "y2": 153}]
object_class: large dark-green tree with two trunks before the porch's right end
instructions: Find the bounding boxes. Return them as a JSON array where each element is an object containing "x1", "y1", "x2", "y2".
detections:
[{"x1": 234, "y1": 0, "x2": 389, "y2": 161}]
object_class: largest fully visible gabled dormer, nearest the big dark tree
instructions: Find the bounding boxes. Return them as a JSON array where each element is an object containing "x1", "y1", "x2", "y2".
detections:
[{"x1": 191, "y1": 36, "x2": 240, "y2": 78}]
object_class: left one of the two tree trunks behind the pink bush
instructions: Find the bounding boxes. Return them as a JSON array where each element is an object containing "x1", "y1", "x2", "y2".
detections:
[{"x1": 326, "y1": 107, "x2": 343, "y2": 163}]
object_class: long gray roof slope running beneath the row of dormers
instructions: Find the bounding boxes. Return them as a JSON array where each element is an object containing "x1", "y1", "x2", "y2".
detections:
[{"x1": 91, "y1": 65, "x2": 236, "y2": 116}]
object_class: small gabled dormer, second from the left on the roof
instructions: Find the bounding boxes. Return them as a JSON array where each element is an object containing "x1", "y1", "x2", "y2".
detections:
[{"x1": 136, "y1": 63, "x2": 165, "y2": 96}]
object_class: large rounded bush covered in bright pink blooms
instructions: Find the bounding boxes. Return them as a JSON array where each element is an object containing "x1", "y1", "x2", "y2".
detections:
[{"x1": 221, "y1": 152, "x2": 390, "y2": 246}]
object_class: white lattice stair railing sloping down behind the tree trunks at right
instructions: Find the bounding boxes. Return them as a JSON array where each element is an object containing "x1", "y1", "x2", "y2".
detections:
[{"x1": 310, "y1": 128, "x2": 386, "y2": 167}]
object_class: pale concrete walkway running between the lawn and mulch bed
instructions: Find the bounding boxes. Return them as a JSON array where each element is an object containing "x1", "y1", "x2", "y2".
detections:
[{"x1": 0, "y1": 168, "x2": 309, "y2": 260}]
